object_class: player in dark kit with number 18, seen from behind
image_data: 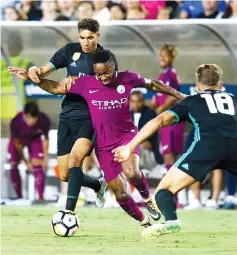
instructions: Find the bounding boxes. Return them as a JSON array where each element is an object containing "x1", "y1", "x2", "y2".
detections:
[{"x1": 113, "y1": 64, "x2": 237, "y2": 238}]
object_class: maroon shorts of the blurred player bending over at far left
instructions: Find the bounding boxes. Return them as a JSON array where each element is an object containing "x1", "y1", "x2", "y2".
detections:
[{"x1": 8, "y1": 138, "x2": 43, "y2": 162}]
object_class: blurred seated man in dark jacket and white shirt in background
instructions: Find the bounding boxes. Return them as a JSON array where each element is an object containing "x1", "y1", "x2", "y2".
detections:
[{"x1": 130, "y1": 90, "x2": 163, "y2": 167}]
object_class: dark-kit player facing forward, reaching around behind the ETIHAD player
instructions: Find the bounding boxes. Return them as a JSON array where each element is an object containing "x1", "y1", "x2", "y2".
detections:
[{"x1": 10, "y1": 18, "x2": 117, "y2": 211}]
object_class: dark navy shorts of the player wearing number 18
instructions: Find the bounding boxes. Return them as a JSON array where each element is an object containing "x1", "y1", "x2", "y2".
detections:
[{"x1": 174, "y1": 137, "x2": 237, "y2": 182}]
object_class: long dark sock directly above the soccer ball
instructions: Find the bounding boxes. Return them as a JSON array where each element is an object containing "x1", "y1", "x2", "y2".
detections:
[{"x1": 66, "y1": 167, "x2": 83, "y2": 211}]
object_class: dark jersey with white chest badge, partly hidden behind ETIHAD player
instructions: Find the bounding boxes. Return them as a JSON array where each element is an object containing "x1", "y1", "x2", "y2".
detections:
[{"x1": 49, "y1": 43, "x2": 117, "y2": 119}]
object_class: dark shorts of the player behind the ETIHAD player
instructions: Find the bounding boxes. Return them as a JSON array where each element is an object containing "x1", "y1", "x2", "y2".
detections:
[{"x1": 57, "y1": 118, "x2": 94, "y2": 156}]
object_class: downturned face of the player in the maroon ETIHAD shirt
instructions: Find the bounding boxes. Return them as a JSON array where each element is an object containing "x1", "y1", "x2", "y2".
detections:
[{"x1": 94, "y1": 63, "x2": 115, "y2": 86}]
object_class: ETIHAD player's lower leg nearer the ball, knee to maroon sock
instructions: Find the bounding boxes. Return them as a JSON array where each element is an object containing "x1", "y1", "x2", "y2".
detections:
[{"x1": 108, "y1": 174, "x2": 151, "y2": 227}]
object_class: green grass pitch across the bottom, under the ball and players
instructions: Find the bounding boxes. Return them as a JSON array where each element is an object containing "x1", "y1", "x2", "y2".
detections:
[{"x1": 1, "y1": 207, "x2": 237, "y2": 255}]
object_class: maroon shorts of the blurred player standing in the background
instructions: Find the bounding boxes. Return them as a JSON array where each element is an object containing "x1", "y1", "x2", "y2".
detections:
[{"x1": 160, "y1": 123, "x2": 184, "y2": 155}]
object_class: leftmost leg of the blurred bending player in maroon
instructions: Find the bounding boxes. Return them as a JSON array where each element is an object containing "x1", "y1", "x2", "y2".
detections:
[{"x1": 8, "y1": 139, "x2": 22, "y2": 198}]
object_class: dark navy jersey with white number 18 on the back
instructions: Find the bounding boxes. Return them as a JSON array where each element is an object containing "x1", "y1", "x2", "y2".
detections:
[{"x1": 168, "y1": 90, "x2": 237, "y2": 140}]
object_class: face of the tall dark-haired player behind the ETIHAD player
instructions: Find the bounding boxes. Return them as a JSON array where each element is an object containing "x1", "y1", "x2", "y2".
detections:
[{"x1": 79, "y1": 30, "x2": 100, "y2": 54}]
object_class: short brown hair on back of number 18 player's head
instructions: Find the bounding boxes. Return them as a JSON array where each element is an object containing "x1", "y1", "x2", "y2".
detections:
[{"x1": 196, "y1": 64, "x2": 223, "y2": 86}]
